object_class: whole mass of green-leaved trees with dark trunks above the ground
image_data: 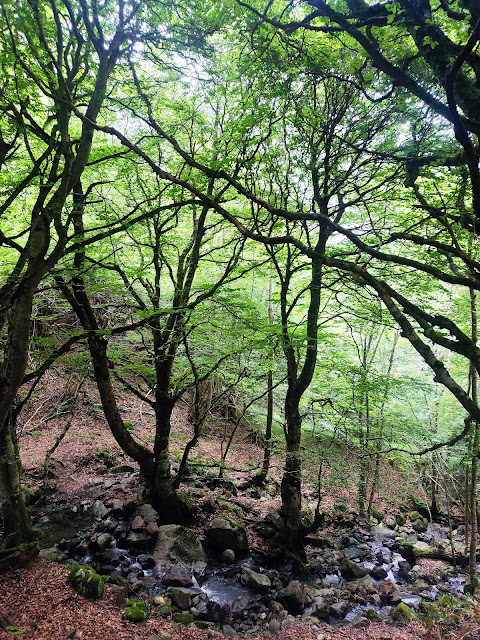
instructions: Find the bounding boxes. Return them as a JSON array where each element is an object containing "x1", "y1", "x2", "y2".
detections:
[{"x1": 0, "y1": 0, "x2": 480, "y2": 592}]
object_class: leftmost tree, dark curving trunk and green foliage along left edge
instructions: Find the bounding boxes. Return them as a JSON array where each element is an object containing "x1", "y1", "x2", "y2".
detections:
[{"x1": 0, "y1": 1, "x2": 140, "y2": 546}]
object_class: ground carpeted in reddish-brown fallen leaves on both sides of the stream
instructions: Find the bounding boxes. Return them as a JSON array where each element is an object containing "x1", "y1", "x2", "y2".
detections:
[{"x1": 0, "y1": 374, "x2": 480, "y2": 640}]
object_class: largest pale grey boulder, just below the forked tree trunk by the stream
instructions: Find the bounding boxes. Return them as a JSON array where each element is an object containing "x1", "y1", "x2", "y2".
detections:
[{"x1": 153, "y1": 524, "x2": 207, "y2": 573}]
